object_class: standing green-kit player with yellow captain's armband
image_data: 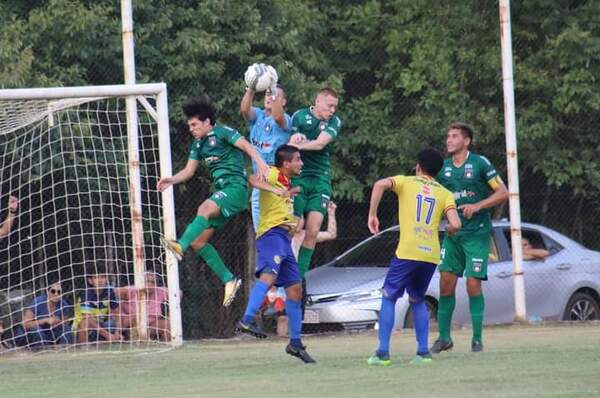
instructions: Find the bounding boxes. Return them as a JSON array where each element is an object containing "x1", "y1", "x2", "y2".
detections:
[{"x1": 431, "y1": 122, "x2": 508, "y2": 354}]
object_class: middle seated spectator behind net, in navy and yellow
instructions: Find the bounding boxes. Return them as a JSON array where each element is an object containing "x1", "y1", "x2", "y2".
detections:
[{"x1": 74, "y1": 264, "x2": 123, "y2": 343}]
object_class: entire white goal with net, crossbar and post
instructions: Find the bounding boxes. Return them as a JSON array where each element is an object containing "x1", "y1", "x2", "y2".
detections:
[{"x1": 0, "y1": 84, "x2": 181, "y2": 353}]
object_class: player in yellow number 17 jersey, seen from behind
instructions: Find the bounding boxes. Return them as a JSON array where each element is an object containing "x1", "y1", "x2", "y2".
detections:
[{"x1": 368, "y1": 149, "x2": 461, "y2": 366}]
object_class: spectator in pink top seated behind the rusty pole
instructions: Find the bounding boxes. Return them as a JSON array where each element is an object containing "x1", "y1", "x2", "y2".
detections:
[{"x1": 117, "y1": 271, "x2": 171, "y2": 341}]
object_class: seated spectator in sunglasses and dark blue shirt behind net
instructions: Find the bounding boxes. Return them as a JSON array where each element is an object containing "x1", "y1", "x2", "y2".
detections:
[{"x1": 15, "y1": 281, "x2": 73, "y2": 348}]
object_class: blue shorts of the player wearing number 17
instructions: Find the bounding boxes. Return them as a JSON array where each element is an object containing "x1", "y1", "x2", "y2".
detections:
[{"x1": 383, "y1": 257, "x2": 436, "y2": 301}]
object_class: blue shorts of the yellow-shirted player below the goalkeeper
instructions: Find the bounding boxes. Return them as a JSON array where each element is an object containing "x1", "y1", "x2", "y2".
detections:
[{"x1": 255, "y1": 227, "x2": 302, "y2": 288}]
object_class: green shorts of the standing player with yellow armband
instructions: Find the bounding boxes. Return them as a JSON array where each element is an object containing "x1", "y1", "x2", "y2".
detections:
[{"x1": 439, "y1": 234, "x2": 490, "y2": 280}]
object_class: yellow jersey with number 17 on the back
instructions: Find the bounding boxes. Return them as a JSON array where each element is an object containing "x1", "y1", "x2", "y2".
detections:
[{"x1": 391, "y1": 176, "x2": 456, "y2": 264}]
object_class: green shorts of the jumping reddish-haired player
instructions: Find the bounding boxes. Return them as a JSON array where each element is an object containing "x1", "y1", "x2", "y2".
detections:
[{"x1": 292, "y1": 177, "x2": 331, "y2": 217}]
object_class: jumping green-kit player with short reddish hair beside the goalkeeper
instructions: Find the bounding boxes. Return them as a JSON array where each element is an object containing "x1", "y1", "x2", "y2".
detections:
[{"x1": 290, "y1": 88, "x2": 342, "y2": 276}]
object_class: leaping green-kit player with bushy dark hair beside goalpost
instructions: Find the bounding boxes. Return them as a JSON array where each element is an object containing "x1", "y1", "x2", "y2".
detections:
[{"x1": 158, "y1": 97, "x2": 269, "y2": 307}]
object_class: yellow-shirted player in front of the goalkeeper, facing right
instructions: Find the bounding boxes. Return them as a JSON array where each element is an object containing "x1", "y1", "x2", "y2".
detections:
[{"x1": 237, "y1": 145, "x2": 315, "y2": 363}]
